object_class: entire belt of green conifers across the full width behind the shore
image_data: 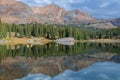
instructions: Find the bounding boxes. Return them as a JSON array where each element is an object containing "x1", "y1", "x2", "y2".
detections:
[{"x1": 0, "y1": 21, "x2": 120, "y2": 40}]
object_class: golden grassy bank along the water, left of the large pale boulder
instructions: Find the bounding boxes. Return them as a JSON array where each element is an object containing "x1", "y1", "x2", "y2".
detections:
[{"x1": 0, "y1": 37, "x2": 52, "y2": 45}]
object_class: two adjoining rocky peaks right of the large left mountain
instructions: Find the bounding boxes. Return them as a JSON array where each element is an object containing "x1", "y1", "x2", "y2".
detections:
[{"x1": 31, "y1": 4, "x2": 95, "y2": 24}]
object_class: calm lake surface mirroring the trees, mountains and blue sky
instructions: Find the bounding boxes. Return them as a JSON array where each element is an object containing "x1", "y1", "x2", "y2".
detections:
[{"x1": 0, "y1": 43, "x2": 120, "y2": 80}]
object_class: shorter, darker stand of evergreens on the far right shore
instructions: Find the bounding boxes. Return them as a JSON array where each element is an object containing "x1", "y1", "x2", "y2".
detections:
[{"x1": 88, "y1": 28, "x2": 120, "y2": 39}]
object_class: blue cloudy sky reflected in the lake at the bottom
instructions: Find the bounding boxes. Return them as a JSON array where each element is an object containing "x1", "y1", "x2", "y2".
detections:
[{"x1": 20, "y1": 62, "x2": 120, "y2": 80}]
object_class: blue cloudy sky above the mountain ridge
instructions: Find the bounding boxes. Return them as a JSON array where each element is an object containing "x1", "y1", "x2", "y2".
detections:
[{"x1": 18, "y1": 0, "x2": 120, "y2": 18}]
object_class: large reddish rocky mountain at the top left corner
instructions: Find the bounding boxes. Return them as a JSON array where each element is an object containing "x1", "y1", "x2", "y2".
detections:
[{"x1": 0, "y1": 0, "x2": 38, "y2": 23}]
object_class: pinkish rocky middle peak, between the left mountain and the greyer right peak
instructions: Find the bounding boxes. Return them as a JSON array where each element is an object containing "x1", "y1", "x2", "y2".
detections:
[{"x1": 31, "y1": 4, "x2": 65, "y2": 23}]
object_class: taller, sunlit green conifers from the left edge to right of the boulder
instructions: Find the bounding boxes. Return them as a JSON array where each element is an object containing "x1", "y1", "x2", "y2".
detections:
[{"x1": 0, "y1": 23, "x2": 88, "y2": 39}]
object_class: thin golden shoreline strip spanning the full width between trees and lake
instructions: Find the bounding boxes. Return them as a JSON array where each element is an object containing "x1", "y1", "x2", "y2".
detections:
[{"x1": 0, "y1": 37, "x2": 120, "y2": 45}]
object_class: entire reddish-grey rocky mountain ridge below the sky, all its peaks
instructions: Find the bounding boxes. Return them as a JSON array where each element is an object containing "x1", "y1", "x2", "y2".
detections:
[{"x1": 0, "y1": 0, "x2": 95, "y2": 24}]
